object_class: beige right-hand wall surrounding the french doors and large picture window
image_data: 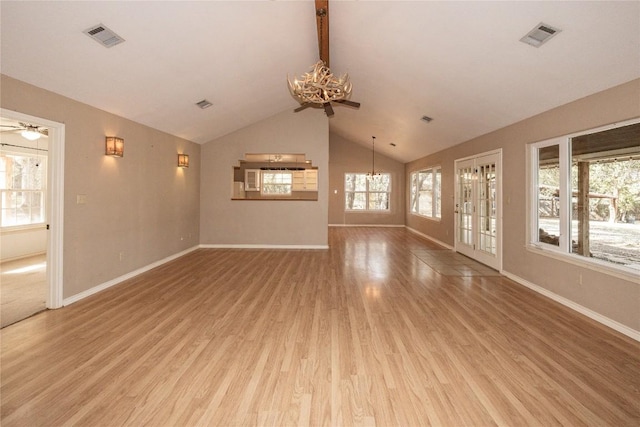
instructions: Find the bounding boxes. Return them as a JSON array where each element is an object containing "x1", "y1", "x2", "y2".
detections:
[{"x1": 406, "y1": 80, "x2": 640, "y2": 331}]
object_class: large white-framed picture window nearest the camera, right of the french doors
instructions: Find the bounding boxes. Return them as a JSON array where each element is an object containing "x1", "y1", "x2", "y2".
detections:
[{"x1": 530, "y1": 120, "x2": 640, "y2": 271}]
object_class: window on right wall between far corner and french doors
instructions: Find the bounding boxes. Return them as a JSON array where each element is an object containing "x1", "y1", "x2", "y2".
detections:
[{"x1": 411, "y1": 166, "x2": 442, "y2": 218}]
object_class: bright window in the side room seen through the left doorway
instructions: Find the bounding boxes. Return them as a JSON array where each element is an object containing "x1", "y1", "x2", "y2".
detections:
[{"x1": 0, "y1": 152, "x2": 47, "y2": 227}]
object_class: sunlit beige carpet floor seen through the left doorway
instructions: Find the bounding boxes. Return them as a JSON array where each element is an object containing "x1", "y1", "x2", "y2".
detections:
[{"x1": 0, "y1": 255, "x2": 47, "y2": 328}]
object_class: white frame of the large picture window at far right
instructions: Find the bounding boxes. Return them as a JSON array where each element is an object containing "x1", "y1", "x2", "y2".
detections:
[{"x1": 527, "y1": 118, "x2": 640, "y2": 283}]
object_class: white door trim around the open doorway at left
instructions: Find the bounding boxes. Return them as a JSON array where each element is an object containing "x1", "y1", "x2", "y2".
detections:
[{"x1": 0, "y1": 108, "x2": 65, "y2": 308}]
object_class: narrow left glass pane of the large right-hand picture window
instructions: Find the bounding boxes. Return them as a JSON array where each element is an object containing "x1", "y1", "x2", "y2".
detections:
[{"x1": 537, "y1": 145, "x2": 560, "y2": 246}]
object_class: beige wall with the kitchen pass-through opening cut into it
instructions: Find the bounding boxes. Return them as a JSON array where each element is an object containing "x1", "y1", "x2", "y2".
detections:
[{"x1": 200, "y1": 108, "x2": 329, "y2": 246}]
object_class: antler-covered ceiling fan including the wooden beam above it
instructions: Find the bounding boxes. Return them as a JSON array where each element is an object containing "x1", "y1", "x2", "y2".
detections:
[{"x1": 287, "y1": 0, "x2": 360, "y2": 117}]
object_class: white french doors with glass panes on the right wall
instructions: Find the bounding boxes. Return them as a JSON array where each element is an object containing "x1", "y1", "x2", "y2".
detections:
[{"x1": 455, "y1": 151, "x2": 502, "y2": 271}]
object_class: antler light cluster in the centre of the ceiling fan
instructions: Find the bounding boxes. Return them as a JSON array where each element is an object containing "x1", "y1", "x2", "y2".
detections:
[{"x1": 287, "y1": 61, "x2": 351, "y2": 104}]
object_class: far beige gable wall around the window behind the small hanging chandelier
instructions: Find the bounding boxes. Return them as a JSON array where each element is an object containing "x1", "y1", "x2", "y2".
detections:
[{"x1": 329, "y1": 134, "x2": 405, "y2": 225}]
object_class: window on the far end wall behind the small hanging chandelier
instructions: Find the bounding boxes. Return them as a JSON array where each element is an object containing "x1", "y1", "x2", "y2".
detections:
[{"x1": 344, "y1": 173, "x2": 391, "y2": 211}]
